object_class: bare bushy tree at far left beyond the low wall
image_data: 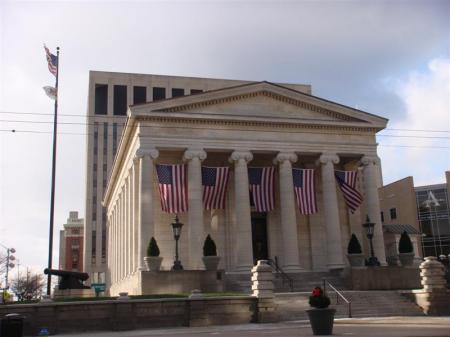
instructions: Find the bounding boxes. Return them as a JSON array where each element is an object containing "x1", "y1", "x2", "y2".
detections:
[{"x1": 10, "y1": 270, "x2": 45, "y2": 301}]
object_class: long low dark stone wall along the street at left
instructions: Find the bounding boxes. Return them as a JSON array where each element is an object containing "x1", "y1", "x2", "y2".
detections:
[{"x1": 0, "y1": 296, "x2": 257, "y2": 336}]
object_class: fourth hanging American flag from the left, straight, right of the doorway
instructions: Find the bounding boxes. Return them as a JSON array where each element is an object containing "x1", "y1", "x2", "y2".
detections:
[{"x1": 292, "y1": 169, "x2": 318, "y2": 214}]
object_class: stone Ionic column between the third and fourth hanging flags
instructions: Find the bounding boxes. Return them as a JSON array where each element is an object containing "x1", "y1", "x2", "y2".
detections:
[{"x1": 274, "y1": 153, "x2": 301, "y2": 272}]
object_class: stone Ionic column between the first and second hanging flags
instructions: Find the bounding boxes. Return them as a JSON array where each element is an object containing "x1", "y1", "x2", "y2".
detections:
[{"x1": 183, "y1": 149, "x2": 206, "y2": 270}]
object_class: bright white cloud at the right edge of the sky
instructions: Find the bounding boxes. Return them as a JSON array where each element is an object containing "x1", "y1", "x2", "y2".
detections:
[{"x1": 380, "y1": 58, "x2": 450, "y2": 186}]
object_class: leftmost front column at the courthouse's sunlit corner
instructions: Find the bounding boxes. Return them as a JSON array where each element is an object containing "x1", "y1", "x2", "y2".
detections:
[{"x1": 136, "y1": 149, "x2": 159, "y2": 270}]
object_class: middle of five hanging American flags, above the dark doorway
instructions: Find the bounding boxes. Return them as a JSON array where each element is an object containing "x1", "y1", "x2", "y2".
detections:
[{"x1": 248, "y1": 167, "x2": 275, "y2": 212}]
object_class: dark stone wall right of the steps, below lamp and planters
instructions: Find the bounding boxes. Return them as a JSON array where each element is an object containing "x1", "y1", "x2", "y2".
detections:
[{"x1": 350, "y1": 267, "x2": 422, "y2": 290}]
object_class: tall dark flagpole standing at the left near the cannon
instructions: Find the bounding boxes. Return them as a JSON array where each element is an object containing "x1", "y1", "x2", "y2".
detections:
[{"x1": 47, "y1": 47, "x2": 59, "y2": 296}]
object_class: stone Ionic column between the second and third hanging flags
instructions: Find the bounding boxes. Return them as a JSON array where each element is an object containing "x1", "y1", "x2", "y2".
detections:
[{"x1": 229, "y1": 151, "x2": 253, "y2": 273}]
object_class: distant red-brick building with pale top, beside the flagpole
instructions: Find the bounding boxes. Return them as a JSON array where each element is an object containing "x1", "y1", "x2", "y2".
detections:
[{"x1": 59, "y1": 211, "x2": 84, "y2": 272}]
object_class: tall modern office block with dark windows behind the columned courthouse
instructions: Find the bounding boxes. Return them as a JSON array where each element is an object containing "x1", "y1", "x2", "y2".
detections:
[{"x1": 84, "y1": 71, "x2": 311, "y2": 283}]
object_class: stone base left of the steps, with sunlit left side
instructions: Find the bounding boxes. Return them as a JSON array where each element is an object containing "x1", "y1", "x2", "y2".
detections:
[{"x1": 109, "y1": 270, "x2": 225, "y2": 296}]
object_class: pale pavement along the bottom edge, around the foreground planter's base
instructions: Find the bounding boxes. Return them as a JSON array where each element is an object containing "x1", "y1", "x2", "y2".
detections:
[{"x1": 58, "y1": 317, "x2": 450, "y2": 337}]
